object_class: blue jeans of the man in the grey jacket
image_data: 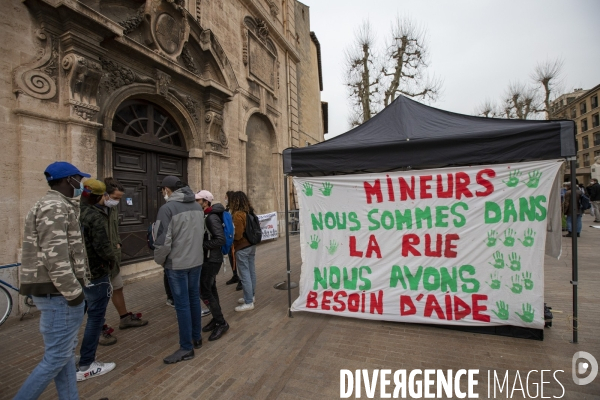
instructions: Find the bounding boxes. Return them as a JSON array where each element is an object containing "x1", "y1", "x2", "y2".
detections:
[{"x1": 165, "y1": 265, "x2": 202, "y2": 351}]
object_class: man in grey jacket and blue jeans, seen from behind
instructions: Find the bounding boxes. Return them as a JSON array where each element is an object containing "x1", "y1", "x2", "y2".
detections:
[{"x1": 154, "y1": 176, "x2": 204, "y2": 364}]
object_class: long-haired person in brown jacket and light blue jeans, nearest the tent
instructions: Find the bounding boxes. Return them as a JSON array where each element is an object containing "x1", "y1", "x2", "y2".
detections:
[{"x1": 229, "y1": 192, "x2": 260, "y2": 312}]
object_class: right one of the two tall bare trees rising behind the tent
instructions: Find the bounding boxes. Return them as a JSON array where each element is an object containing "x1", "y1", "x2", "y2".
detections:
[{"x1": 381, "y1": 17, "x2": 441, "y2": 107}]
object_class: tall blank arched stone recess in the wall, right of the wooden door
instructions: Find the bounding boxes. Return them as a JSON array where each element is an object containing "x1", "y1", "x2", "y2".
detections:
[{"x1": 246, "y1": 114, "x2": 277, "y2": 214}]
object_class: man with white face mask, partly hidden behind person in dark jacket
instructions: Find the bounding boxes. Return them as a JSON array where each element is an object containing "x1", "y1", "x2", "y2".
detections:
[{"x1": 99, "y1": 177, "x2": 148, "y2": 346}]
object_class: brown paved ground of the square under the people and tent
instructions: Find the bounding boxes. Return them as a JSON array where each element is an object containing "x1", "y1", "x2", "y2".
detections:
[{"x1": 0, "y1": 215, "x2": 600, "y2": 400}]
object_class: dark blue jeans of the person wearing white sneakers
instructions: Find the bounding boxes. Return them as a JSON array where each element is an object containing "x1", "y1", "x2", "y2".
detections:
[{"x1": 79, "y1": 275, "x2": 111, "y2": 367}]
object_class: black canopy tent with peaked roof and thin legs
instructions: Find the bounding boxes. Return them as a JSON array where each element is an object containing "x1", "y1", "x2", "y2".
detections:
[{"x1": 283, "y1": 96, "x2": 577, "y2": 342}]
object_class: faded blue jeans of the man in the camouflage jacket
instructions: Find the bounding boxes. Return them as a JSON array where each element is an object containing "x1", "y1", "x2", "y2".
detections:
[{"x1": 15, "y1": 296, "x2": 84, "y2": 400}]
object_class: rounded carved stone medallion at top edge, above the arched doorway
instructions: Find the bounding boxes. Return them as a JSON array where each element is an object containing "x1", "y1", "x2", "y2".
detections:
[{"x1": 144, "y1": 0, "x2": 190, "y2": 61}]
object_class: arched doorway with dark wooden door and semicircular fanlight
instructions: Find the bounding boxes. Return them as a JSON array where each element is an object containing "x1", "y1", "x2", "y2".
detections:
[{"x1": 112, "y1": 99, "x2": 187, "y2": 264}]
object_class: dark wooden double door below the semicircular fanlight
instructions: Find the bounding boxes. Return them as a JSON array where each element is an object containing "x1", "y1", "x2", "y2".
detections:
[{"x1": 113, "y1": 145, "x2": 187, "y2": 264}]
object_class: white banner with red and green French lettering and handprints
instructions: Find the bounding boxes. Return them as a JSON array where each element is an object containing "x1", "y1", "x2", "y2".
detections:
[{"x1": 292, "y1": 160, "x2": 561, "y2": 328}]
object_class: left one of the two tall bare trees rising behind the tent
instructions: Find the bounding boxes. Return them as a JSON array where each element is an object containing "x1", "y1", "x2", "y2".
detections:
[{"x1": 346, "y1": 21, "x2": 379, "y2": 126}]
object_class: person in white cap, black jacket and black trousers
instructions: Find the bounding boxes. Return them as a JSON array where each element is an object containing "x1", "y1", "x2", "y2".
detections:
[{"x1": 196, "y1": 190, "x2": 229, "y2": 341}]
